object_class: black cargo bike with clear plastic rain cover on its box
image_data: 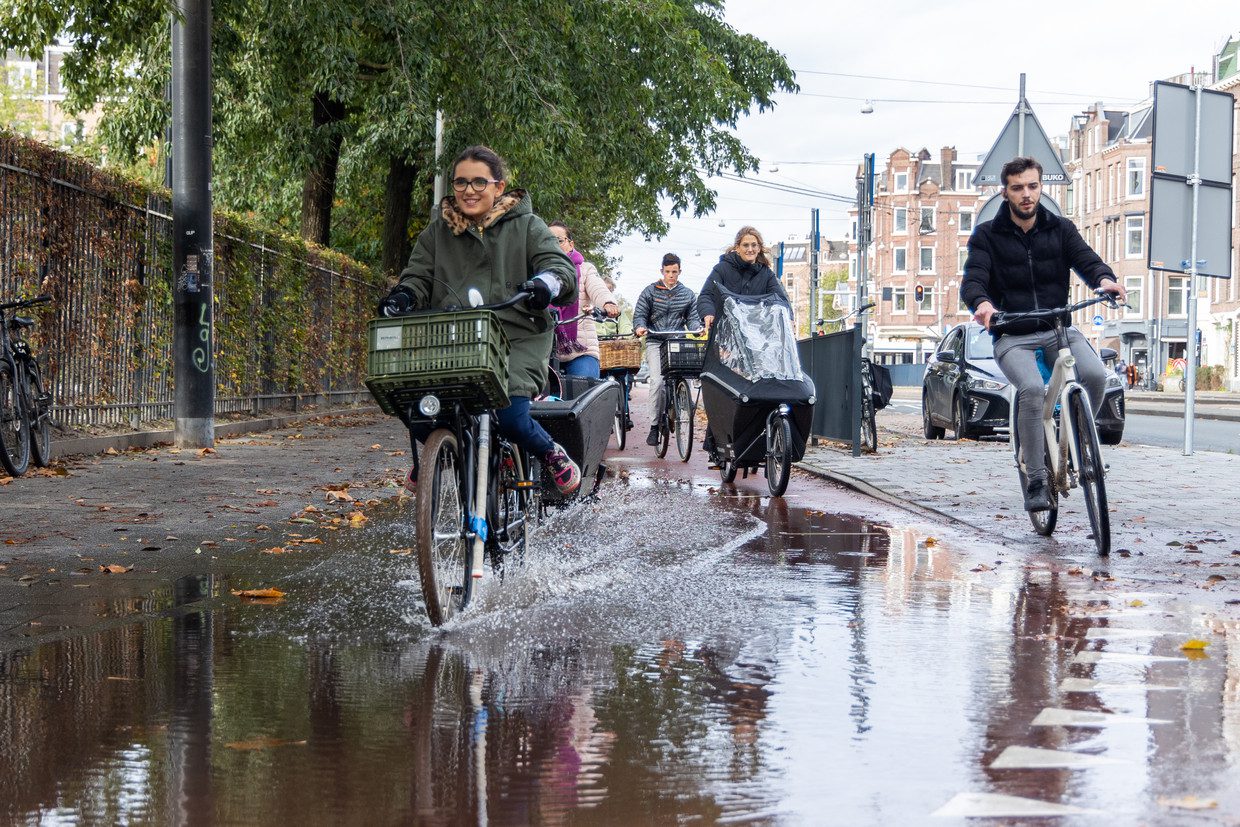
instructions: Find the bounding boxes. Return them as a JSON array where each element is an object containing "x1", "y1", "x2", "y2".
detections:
[{"x1": 701, "y1": 291, "x2": 816, "y2": 497}]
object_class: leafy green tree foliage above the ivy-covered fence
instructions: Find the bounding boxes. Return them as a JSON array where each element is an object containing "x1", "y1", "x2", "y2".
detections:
[{"x1": 0, "y1": 0, "x2": 796, "y2": 272}]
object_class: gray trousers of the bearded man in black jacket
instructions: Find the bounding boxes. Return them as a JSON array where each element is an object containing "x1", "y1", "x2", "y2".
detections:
[{"x1": 994, "y1": 327, "x2": 1106, "y2": 479}]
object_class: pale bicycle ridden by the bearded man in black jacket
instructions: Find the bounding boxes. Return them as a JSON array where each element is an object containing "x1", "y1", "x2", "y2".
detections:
[{"x1": 991, "y1": 294, "x2": 1120, "y2": 557}]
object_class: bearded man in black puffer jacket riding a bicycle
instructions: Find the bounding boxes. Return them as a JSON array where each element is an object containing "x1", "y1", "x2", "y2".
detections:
[{"x1": 960, "y1": 157, "x2": 1127, "y2": 511}]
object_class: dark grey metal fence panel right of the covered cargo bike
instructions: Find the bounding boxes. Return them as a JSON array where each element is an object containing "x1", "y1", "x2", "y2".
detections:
[{"x1": 796, "y1": 327, "x2": 862, "y2": 455}]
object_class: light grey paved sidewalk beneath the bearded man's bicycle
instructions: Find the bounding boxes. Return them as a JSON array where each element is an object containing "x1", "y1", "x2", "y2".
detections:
[{"x1": 800, "y1": 410, "x2": 1240, "y2": 599}]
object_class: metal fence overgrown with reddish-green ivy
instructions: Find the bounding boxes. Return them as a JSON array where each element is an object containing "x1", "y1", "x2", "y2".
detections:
[{"x1": 0, "y1": 134, "x2": 383, "y2": 428}]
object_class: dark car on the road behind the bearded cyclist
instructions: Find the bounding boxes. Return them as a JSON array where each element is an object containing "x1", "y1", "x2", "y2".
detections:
[{"x1": 921, "y1": 321, "x2": 1123, "y2": 445}]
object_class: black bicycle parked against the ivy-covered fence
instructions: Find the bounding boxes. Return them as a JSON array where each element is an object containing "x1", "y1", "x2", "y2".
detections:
[{"x1": 0, "y1": 296, "x2": 52, "y2": 476}]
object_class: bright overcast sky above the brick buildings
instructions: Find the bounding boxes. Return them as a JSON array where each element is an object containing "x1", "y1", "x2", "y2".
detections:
[{"x1": 609, "y1": 0, "x2": 1240, "y2": 301}]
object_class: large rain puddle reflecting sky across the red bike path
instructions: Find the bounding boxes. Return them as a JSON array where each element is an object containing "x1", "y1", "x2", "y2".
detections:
[{"x1": 0, "y1": 471, "x2": 1240, "y2": 825}]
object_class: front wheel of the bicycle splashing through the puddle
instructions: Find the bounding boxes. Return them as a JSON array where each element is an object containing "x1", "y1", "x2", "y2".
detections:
[{"x1": 415, "y1": 429, "x2": 474, "y2": 626}]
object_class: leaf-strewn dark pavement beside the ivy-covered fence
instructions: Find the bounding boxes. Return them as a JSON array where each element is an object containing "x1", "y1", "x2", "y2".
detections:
[{"x1": 0, "y1": 413, "x2": 409, "y2": 651}]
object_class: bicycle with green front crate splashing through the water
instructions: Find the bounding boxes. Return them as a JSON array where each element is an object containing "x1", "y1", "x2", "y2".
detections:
[{"x1": 366, "y1": 290, "x2": 619, "y2": 626}]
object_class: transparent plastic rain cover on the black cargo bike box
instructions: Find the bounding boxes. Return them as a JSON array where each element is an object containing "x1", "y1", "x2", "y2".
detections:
[{"x1": 715, "y1": 296, "x2": 801, "y2": 382}]
